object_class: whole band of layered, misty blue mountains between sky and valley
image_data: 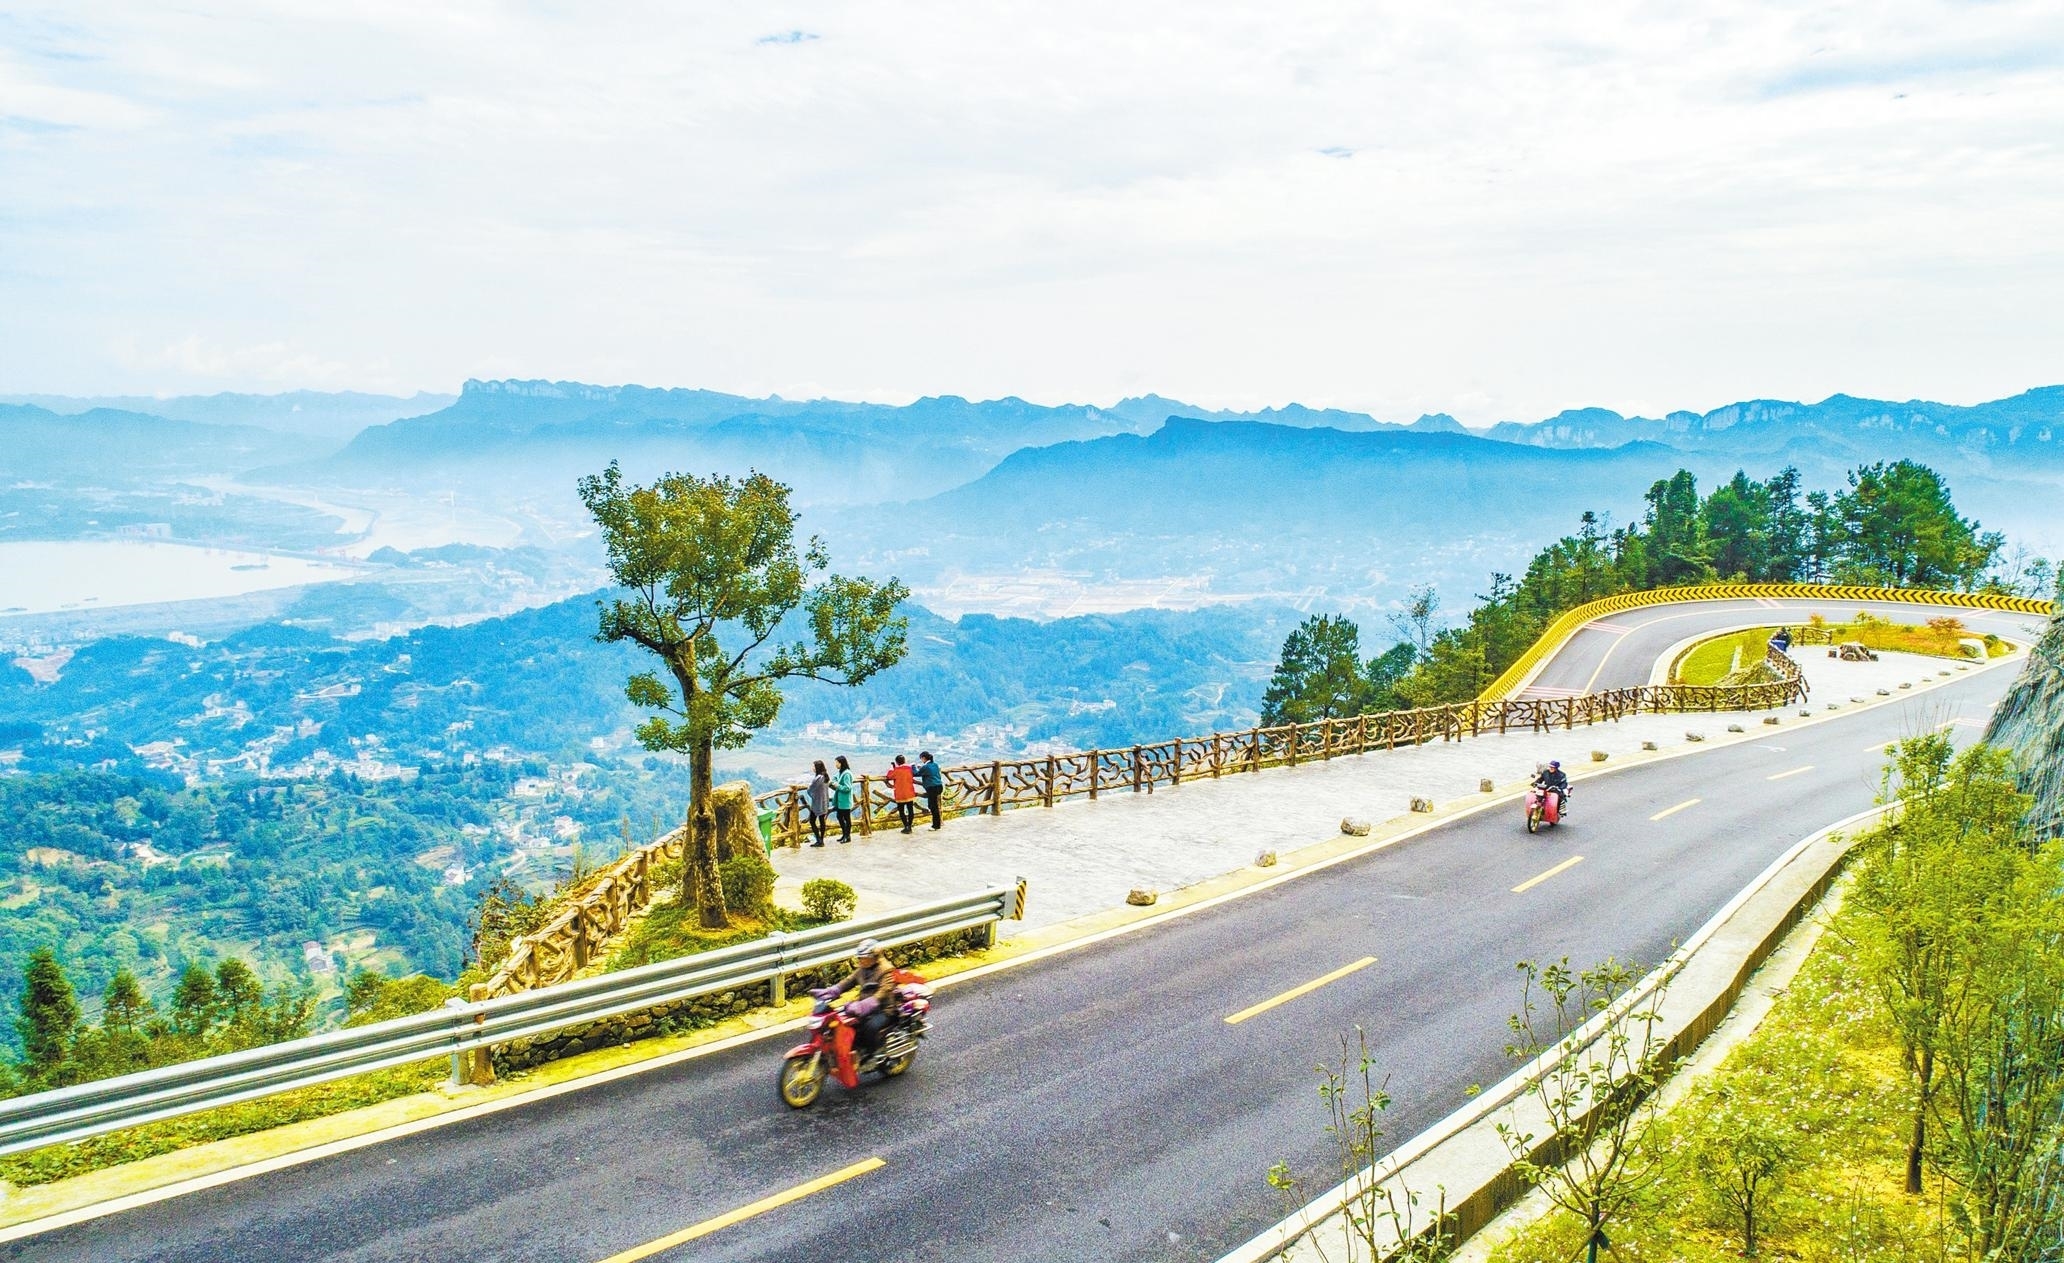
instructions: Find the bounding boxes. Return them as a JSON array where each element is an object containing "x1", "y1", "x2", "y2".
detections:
[{"x1": 16, "y1": 382, "x2": 2064, "y2": 574}]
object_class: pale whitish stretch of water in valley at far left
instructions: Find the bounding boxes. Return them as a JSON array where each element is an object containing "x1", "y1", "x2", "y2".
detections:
[{"x1": 0, "y1": 539, "x2": 359, "y2": 617}]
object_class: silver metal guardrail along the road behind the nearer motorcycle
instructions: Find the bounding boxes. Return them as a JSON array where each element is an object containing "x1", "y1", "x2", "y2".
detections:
[{"x1": 0, "y1": 881, "x2": 1026, "y2": 1154}]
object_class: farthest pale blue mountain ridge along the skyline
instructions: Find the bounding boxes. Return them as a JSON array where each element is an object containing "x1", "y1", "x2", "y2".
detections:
[{"x1": 16, "y1": 382, "x2": 2064, "y2": 482}]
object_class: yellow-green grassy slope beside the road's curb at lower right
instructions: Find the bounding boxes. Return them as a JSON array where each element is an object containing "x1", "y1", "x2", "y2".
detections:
[{"x1": 1490, "y1": 914, "x2": 1957, "y2": 1263}]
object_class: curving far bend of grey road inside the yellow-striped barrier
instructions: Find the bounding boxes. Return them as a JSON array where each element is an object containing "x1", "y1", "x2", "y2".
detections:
[{"x1": 1519, "y1": 598, "x2": 2043, "y2": 698}]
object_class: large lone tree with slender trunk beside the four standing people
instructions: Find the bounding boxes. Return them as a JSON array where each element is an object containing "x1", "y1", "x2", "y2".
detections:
[{"x1": 580, "y1": 462, "x2": 908, "y2": 929}]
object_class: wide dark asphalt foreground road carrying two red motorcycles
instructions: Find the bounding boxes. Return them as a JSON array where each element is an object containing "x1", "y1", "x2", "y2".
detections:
[{"x1": 0, "y1": 652, "x2": 2012, "y2": 1263}]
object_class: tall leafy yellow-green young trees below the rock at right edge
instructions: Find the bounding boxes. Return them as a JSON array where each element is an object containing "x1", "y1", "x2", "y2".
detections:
[{"x1": 1849, "y1": 733, "x2": 2064, "y2": 1261}]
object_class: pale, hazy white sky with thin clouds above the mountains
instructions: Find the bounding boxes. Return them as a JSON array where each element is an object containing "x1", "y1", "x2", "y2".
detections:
[{"x1": 0, "y1": 0, "x2": 2064, "y2": 421}]
